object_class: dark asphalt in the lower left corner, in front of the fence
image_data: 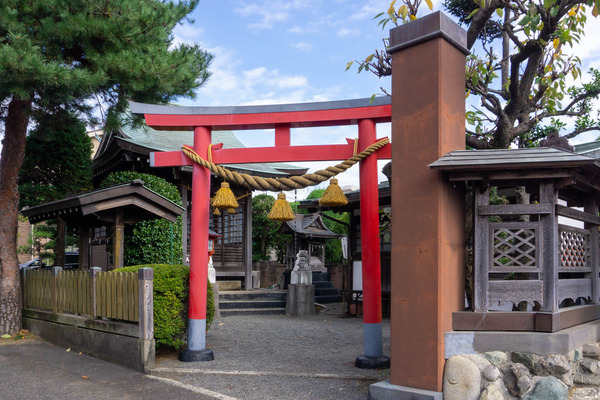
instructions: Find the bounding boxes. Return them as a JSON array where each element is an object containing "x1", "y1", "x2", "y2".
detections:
[{"x1": 0, "y1": 339, "x2": 219, "y2": 400}]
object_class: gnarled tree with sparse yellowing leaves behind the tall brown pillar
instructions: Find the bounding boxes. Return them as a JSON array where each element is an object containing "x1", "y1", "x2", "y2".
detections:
[{"x1": 346, "y1": 0, "x2": 600, "y2": 149}]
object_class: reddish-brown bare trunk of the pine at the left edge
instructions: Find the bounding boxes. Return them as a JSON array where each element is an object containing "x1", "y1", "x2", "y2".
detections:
[{"x1": 0, "y1": 97, "x2": 31, "y2": 335}]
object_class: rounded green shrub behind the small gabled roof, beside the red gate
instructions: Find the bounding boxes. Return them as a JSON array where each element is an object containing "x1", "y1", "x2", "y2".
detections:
[{"x1": 100, "y1": 171, "x2": 183, "y2": 265}]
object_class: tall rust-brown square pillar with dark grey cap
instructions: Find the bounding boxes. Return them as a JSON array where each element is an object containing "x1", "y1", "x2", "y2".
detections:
[{"x1": 390, "y1": 12, "x2": 467, "y2": 392}]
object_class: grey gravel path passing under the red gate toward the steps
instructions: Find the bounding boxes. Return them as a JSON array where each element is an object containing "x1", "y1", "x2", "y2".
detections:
[{"x1": 150, "y1": 304, "x2": 390, "y2": 400}]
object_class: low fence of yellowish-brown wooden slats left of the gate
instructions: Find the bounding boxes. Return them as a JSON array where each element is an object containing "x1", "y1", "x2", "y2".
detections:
[{"x1": 23, "y1": 267, "x2": 152, "y2": 328}]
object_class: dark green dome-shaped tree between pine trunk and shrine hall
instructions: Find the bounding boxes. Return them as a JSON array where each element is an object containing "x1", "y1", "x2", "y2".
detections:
[{"x1": 19, "y1": 110, "x2": 92, "y2": 207}]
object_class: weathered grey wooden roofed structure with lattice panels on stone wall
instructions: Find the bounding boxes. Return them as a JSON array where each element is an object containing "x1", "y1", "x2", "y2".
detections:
[{"x1": 431, "y1": 147, "x2": 600, "y2": 332}]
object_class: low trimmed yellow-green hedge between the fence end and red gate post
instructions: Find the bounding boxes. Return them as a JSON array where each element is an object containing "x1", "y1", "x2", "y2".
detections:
[{"x1": 115, "y1": 264, "x2": 215, "y2": 350}]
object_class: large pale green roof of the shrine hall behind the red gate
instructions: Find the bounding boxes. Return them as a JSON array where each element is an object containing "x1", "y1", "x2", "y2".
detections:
[{"x1": 94, "y1": 125, "x2": 307, "y2": 177}]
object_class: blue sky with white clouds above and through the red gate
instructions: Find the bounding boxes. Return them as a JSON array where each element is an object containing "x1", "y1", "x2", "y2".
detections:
[{"x1": 170, "y1": 0, "x2": 600, "y2": 198}]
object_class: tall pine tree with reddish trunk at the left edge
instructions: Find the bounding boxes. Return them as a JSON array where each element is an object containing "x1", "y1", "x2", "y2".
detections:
[{"x1": 0, "y1": 0, "x2": 211, "y2": 334}]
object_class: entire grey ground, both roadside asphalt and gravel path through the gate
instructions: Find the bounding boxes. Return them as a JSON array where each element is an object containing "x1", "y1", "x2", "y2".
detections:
[{"x1": 0, "y1": 306, "x2": 390, "y2": 400}]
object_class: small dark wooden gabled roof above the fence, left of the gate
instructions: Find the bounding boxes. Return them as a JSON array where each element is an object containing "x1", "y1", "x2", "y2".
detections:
[{"x1": 21, "y1": 179, "x2": 183, "y2": 227}]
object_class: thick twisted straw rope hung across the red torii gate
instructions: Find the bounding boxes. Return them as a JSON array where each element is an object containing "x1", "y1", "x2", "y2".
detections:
[{"x1": 181, "y1": 138, "x2": 390, "y2": 192}]
